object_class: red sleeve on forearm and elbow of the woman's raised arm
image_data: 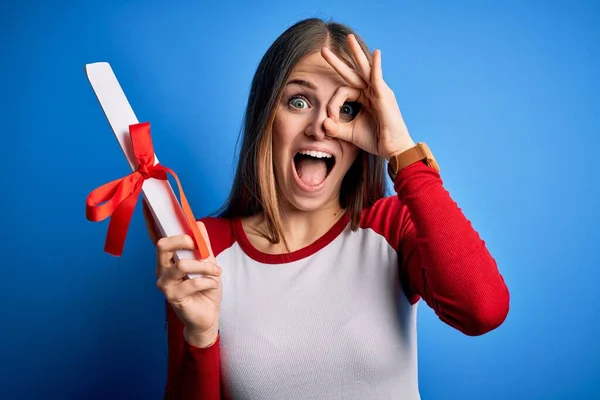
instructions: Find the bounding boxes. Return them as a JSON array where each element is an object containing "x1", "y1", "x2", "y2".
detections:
[{"x1": 394, "y1": 162, "x2": 509, "y2": 336}]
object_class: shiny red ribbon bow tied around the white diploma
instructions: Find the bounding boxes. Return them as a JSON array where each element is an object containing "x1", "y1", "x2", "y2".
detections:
[{"x1": 85, "y1": 122, "x2": 209, "y2": 259}]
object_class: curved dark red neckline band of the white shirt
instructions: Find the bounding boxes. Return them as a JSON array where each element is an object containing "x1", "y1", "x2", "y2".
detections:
[{"x1": 233, "y1": 212, "x2": 350, "y2": 264}]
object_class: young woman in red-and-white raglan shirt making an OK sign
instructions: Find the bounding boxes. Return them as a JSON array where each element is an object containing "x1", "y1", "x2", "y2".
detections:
[{"x1": 147, "y1": 19, "x2": 509, "y2": 400}]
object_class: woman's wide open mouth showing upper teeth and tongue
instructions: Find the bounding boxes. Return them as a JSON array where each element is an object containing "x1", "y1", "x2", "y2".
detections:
[{"x1": 294, "y1": 150, "x2": 335, "y2": 189}]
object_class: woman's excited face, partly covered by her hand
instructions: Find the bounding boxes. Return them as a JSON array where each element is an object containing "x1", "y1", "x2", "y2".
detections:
[{"x1": 273, "y1": 52, "x2": 358, "y2": 211}]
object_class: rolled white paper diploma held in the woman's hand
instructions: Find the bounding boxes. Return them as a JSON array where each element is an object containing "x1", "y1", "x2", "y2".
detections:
[{"x1": 85, "y1": 62, "x2": 200, "y2": 278}]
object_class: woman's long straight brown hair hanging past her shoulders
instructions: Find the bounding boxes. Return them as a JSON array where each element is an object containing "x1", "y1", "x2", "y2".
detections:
[{"x1": 218, "y1": 18, "x2": 386, "y2": 248}]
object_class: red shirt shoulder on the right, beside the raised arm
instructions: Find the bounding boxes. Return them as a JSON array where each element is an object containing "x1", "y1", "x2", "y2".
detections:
[{"x1": 360, "y1": 195, "x2": 410, "y2": 249}]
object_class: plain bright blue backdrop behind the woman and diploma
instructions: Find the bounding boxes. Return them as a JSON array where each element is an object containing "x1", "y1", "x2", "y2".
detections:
[{"x1": 0, "y1": 0, "x2": 600, "y2": 400}]
